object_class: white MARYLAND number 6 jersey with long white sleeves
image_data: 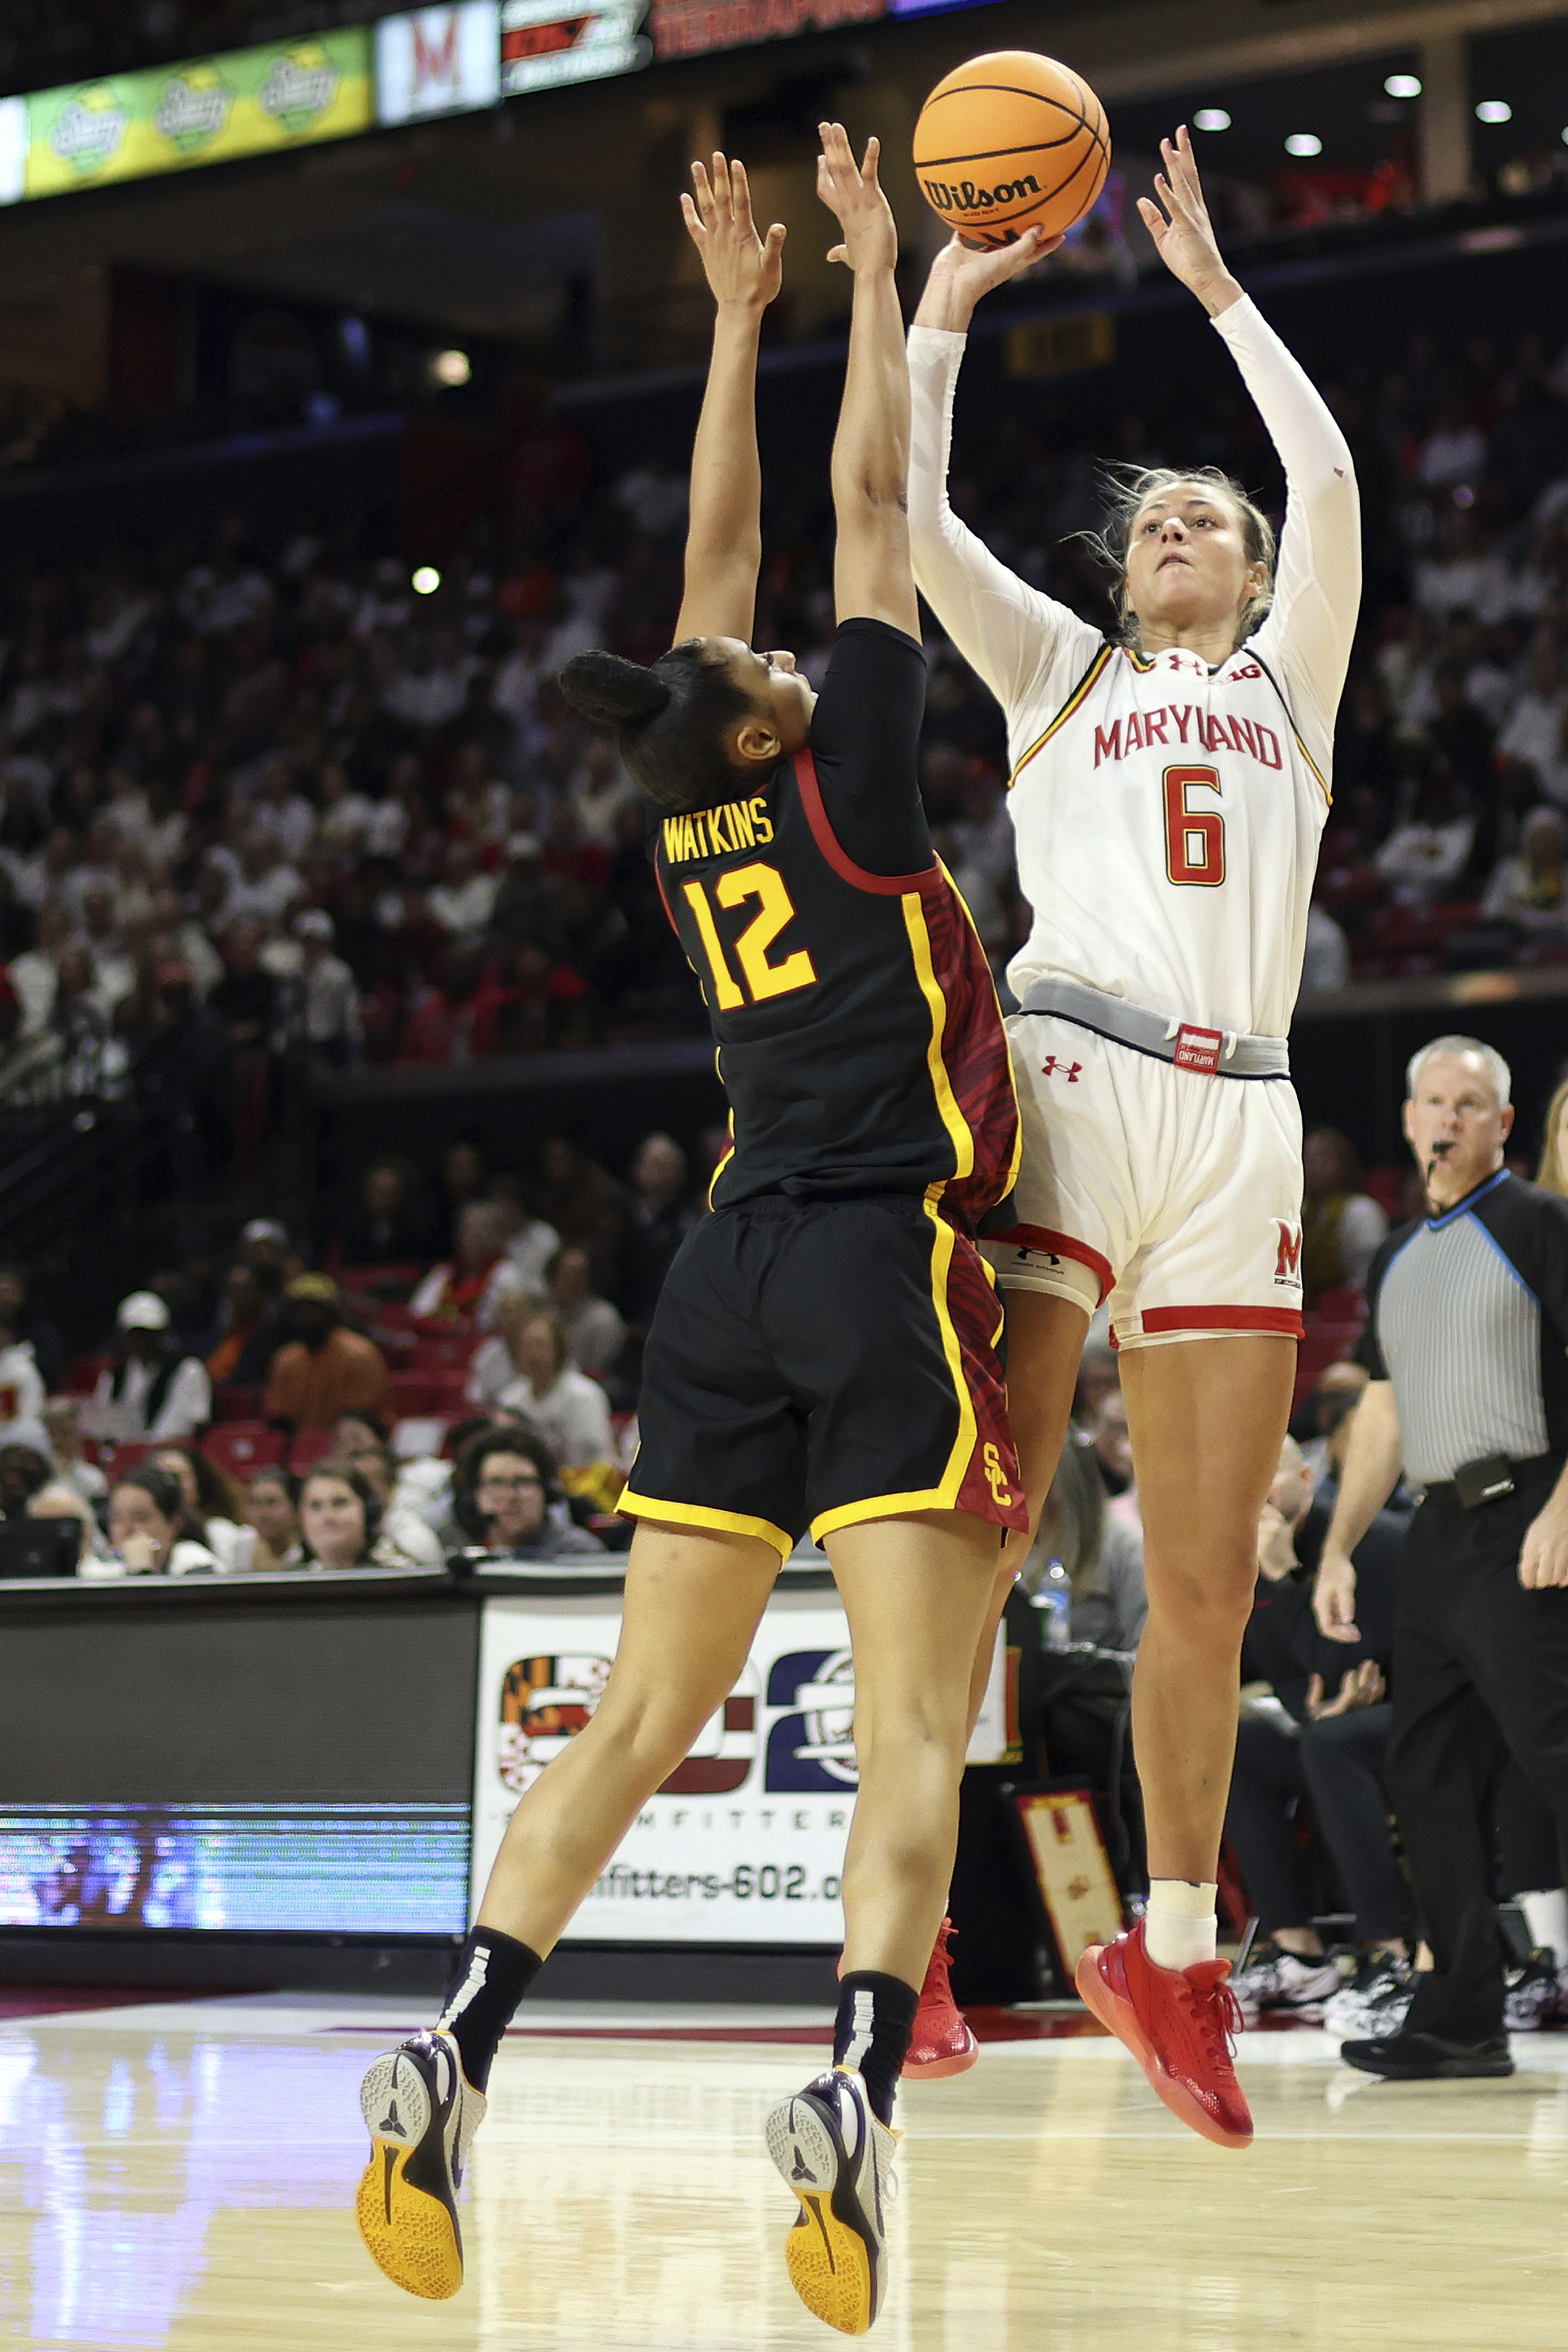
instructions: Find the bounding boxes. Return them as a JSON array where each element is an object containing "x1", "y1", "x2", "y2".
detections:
[{"x1": 910, "y1": 299, "x2": 1361, "y2": 1037}]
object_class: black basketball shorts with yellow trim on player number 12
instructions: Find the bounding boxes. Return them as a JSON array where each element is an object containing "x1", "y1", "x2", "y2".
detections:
[{"x1": 621, "y1": 1195, "x2": 1027, "y2": 1555}]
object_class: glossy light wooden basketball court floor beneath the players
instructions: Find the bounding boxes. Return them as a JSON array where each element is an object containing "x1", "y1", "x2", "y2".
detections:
[{"x1": 0, "y1": 1997, "x2": 1568, "y2": 2352}]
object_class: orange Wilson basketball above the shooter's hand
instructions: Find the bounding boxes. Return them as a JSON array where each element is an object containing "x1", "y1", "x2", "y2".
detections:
[{"x1": 915, "y1": 50, "x2": 1109, "y2": 247}]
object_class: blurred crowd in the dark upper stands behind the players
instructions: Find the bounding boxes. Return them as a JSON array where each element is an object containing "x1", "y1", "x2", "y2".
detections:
[{"x1": 0, "y1": 312, "x2": 1568, "y2": 1147}]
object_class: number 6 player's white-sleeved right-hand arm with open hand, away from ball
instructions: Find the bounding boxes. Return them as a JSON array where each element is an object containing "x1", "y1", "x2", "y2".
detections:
[{"x1": 1138, "y1": 125, "x2": 1361, "y2": 736}]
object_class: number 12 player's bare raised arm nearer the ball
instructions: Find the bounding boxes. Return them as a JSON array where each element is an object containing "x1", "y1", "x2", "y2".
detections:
[{"x1": 816, "y1": 122, "x2": 919, "y2": 638}]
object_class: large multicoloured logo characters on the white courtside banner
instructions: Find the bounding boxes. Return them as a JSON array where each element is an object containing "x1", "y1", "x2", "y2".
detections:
[{"x1": 496, "y1": 1649, "x2": 858, "y2": 1797}]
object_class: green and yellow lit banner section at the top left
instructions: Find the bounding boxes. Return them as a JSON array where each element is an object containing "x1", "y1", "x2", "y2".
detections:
[{"x1": 26, "y1": 26, "x2": 374, "y2": 195}]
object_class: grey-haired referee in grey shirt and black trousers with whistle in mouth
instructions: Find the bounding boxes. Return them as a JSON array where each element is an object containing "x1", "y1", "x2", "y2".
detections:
[{"x1": 1316, "y1": 1037, "x2": 1568, "y2": 2082}]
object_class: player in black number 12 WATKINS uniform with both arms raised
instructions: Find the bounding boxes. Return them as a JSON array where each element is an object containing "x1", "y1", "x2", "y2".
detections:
[{"x1": 360, "y1": 125, "x2": 1025, "y2": 2333}]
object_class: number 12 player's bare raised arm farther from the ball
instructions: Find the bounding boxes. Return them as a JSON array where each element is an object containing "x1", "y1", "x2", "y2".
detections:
[{"x1": 675, "y1": 155, "x2": 785, "y2": 644}]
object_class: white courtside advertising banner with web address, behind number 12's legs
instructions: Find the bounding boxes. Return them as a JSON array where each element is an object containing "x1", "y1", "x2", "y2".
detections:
[{"x1": 472, "y1": 1592, "x2": 1009, "y2": 1945}]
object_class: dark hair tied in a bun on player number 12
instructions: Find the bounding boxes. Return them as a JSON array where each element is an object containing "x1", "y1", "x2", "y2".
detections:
[{"x1": 559, "y1": 638, "x2": 752, "y2": 809}]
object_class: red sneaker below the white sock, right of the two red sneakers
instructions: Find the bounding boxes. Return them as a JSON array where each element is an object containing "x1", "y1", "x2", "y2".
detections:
[{"x1": 1077, "y1": 1919, "x2": 1253, "y2": 2148}]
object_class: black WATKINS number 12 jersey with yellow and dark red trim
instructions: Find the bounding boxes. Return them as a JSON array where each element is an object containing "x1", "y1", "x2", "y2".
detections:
[{"x1": 653, "y1": 621, "x2": 1018, "y2": 1230}]
